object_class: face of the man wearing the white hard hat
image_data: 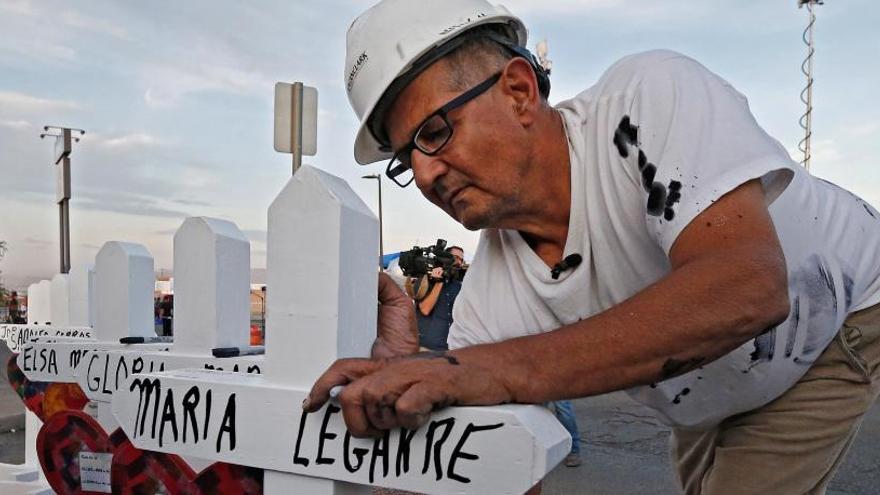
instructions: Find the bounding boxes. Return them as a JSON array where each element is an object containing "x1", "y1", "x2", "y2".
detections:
[{"x1": 385, "y1": 60, "x2": 529, "y2": 230}]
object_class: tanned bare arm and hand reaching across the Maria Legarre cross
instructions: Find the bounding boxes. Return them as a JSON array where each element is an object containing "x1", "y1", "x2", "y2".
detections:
[{"x1": 304, "y1": 181, "x2": 789, "y2": 435}]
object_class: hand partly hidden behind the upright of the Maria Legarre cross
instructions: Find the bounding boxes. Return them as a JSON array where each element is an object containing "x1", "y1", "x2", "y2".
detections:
[{"x1": 370, "y1": 273, "x2": 419, "y2": 358}]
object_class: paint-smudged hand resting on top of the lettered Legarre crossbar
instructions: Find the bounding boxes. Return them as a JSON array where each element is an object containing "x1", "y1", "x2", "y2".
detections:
[{"x1": 303, "y1": 352, "x2": 511, "y2": 437}]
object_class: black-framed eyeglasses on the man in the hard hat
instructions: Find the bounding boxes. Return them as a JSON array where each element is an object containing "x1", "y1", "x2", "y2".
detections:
[{"x1": 385, "y1": 72, "x2": 501, "y2": 187}]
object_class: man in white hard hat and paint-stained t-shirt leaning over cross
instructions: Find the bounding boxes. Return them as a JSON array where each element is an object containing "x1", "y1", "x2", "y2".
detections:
[{"x1": 304, "y1": 0, "x2": 880, "y2": 493}]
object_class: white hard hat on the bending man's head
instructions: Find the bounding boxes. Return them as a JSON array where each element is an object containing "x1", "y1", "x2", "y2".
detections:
[{"x1": 344, "y1": 0, "x2": 528, "y2": 165}]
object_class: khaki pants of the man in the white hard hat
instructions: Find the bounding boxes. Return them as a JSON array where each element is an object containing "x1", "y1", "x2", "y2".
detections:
[{"x1": 671, "y1": 305, "x2": 880, "y2": 495}]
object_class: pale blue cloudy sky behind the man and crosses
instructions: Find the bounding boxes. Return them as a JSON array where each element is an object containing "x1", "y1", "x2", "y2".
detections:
[{"x1": 0, "y1": 0, "x2": 880, "y2": 288}]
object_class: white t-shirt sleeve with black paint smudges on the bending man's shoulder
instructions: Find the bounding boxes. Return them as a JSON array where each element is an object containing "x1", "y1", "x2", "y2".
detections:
[{"x1": 614, "y1": 52, "x2": 796, "y2": 255}]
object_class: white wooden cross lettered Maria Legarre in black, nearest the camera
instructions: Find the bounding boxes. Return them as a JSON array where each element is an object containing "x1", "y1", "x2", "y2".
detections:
[{"x1": 113, "y1": 167, "x2": 571, "y2": 495}]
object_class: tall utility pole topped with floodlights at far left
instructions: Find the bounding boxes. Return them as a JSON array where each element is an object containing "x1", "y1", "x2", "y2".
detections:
[{"x1": 40, "y1": 125, "x2": 86, "y2": 273}]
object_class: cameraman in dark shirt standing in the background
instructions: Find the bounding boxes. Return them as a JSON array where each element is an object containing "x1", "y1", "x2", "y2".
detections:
[{"x1": 416, "y1": 246, "x2": 464, "y2": 351}]
